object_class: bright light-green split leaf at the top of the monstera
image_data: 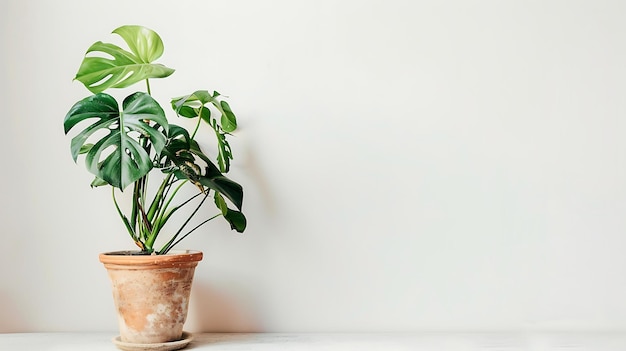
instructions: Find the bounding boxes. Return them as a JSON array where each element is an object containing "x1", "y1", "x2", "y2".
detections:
[{"x1": 75, "y1": 26, "x2": 174, "y2": 93}]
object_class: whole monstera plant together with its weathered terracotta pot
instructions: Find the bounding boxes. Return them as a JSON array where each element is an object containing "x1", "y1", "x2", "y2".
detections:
[{"x1": 64, "y1": 25, "x2": 246, "y2": 349}]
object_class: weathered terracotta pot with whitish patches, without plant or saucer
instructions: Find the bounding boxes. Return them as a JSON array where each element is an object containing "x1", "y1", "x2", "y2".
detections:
[{"x1": 99, "y1": 251, "x2": 202, "y2": 344}]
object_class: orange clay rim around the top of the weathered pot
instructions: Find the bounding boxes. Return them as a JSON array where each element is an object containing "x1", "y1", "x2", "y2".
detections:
[{"x1": 98, "y1": 250, "x2": 202, "y2": 266}]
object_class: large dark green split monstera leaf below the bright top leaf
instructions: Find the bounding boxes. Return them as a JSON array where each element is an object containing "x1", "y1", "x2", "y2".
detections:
[{"x1": 64, "y1": 92, "x2": 168, "y2": 190}]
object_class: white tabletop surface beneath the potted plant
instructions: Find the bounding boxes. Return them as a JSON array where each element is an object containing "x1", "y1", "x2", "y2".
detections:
[{"x1": 0, "y1": 332, "x2": 626, "y2": 351}]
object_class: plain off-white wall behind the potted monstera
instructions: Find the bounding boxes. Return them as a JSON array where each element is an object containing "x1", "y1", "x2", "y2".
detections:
[{"x1": 0, "y1": 0, "x2": 626, "y2": 332}]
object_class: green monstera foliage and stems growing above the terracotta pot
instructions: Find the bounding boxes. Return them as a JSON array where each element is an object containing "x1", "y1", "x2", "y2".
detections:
[{"x1": 64, "y1": 25, "x2": 246, "y2": 255}]
